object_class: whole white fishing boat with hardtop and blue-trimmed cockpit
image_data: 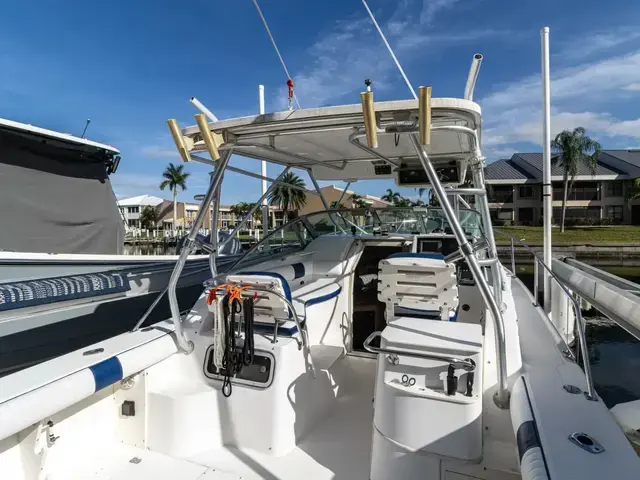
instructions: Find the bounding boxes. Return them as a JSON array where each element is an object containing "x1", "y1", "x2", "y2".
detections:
[{"x1": 0, "y1": 27, "x2": 640, "y2": 480}]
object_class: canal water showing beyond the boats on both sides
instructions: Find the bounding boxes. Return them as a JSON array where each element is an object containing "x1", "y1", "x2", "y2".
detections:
[{"x1": 125, "y1": 245, "x2": 640, "y2": 407}]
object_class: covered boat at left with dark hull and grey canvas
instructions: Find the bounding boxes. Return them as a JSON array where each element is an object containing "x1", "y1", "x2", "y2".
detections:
[{"x1": 0, "y1": 119, "x2": 237, "y2": 374}]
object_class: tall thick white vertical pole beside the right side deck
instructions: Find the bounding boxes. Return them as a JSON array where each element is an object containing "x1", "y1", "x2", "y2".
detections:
[{"x1": 536, "y1": 27, "x2": 553, "y2": 313}]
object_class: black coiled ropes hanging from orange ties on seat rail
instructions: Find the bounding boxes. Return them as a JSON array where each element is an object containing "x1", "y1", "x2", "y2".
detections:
[{"x1": 222, "y1": 294, "x2": 255, "y2": 397}]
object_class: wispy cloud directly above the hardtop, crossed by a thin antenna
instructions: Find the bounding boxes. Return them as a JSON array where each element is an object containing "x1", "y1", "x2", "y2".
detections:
[{"x1": 275, "y1": 0, "x2": 509, "y2": 110}]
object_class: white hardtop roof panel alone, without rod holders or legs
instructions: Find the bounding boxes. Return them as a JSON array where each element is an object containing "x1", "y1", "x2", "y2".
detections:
[{"x1": 183, "y1": 98, "x2": 481, "y2": 186}]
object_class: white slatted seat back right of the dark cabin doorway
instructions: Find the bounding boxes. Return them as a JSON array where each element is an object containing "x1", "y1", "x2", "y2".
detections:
[{"x1": 378, "y1": 253, "x2": 458, "y2": 322}]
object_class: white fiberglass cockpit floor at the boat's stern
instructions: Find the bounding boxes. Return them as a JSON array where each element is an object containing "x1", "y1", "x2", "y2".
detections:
[{"x1": 65, "y1": 356, "x2": 376, "y2": 480}]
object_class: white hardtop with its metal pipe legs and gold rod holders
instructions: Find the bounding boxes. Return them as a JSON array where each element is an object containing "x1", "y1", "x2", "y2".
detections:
[{"x1": 162, "y1": 67, "x2": 509, "y2": 406}]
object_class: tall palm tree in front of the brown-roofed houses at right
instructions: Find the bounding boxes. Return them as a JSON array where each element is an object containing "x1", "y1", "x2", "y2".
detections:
[{"x1": 551, "y1": 127, "x2": 602, "y2": 232}]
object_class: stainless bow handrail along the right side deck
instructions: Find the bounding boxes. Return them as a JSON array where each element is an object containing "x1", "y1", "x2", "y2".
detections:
[{"x1": 494, "y1": 228, "x2": 598, "y2": 402}]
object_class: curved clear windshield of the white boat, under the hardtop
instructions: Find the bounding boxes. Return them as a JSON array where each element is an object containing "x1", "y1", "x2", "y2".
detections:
[{"x1": 232, "y1": 207, "x2": 484, "y2": 264}]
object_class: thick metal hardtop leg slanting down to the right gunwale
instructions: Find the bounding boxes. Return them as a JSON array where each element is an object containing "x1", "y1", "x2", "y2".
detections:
[{"x1": 409, "y1": 135, "x2": 509, "y2": 408}]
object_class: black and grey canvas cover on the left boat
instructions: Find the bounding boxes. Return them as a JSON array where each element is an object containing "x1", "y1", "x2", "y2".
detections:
[{"x1": 0, "y1": 125, "x2": 124, "y2": 254}]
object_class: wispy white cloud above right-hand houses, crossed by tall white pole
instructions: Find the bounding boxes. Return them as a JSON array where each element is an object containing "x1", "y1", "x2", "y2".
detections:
[{"x1": 479, "y1": 51, "x2": 640, "y2": 151}]
